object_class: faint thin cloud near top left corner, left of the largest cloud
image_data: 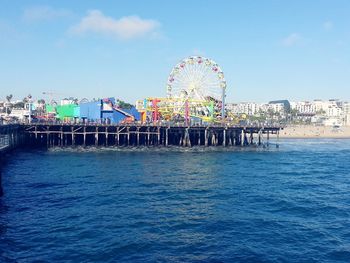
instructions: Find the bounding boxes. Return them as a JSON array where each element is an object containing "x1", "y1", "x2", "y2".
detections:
[{"x1": 23, "y1": 6, "x2": 72, "y2": 22}]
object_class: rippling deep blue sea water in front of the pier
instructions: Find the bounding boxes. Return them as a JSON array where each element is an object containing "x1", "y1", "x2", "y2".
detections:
[{"x1": 0, "y1": 139, "x2": 350, "y2": 262}]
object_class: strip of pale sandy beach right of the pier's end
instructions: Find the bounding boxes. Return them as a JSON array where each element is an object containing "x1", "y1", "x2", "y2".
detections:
[{"x1": 280, "y1": 125, "x2": 350, "y2": 139}]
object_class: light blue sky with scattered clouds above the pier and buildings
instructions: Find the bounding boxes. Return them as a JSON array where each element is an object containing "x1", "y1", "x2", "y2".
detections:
[{"x1": 0, "y1": 0, "x2": 350, "y2": 103}]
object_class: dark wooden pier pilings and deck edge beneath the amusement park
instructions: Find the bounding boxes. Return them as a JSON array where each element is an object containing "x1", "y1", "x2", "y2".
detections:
[{"x1": 22, "y1": 124, "x2": 281, "y2": 148}]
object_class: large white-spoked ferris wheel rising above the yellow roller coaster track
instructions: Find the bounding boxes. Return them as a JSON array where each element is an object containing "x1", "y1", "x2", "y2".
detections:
[{"x1": 167, "y1": 56, "x2": 226, "y2": 102}]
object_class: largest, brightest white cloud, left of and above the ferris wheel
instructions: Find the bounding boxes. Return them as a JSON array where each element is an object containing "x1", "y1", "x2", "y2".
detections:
[{"x1": 69, "y1": 10, "x2": 159, "y2": 40}]
